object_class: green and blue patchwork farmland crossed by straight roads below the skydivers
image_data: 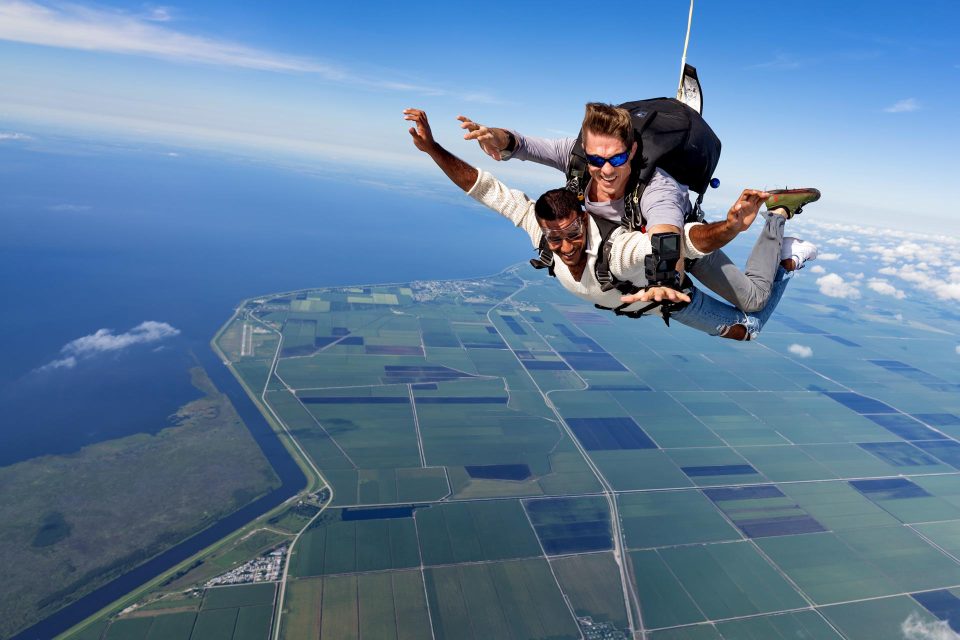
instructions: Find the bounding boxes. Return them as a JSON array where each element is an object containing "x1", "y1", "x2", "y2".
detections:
[{"x1": 90, "y1": 256, "x2": 960, "y2": 640}]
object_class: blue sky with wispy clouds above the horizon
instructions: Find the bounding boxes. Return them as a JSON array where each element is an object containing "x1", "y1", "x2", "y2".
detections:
[{"x1": 0, "y1": 0, "x2": 960, "y2": 233}]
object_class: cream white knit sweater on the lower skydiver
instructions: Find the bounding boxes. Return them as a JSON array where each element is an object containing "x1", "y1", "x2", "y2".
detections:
[{"x1": 467, "y1": 171, "x2": 705, "y2": 314}]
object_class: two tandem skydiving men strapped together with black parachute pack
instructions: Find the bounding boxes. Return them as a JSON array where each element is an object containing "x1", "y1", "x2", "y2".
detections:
[{"x1": 404, "y1": 100, "x2": 820, "y2": 340}]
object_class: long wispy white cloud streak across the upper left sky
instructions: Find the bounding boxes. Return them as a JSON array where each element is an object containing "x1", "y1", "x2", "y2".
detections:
[{"x1": 0, "y1": 0, "x2": 497, "y2": 103}]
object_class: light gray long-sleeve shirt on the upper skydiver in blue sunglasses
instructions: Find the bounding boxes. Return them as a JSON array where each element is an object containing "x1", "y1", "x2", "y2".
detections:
[{"x1": 510, "y1": 131, "x2": 693, "y2": 229}]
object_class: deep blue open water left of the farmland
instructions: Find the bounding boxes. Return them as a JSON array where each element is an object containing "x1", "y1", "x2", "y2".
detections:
[{"x1": 0, "y1": 135, "x2": 527, "y2": 466}]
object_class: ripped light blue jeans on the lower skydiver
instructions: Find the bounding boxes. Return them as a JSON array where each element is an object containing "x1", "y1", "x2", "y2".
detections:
[{"x1": 670, "y1": 267, "x2": 795, "y2": 340}]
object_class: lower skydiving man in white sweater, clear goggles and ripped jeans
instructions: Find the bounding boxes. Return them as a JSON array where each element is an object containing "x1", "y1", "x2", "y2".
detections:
[{"x1": 404, "y1": 109, "x2": 810, "y2": 340}]
